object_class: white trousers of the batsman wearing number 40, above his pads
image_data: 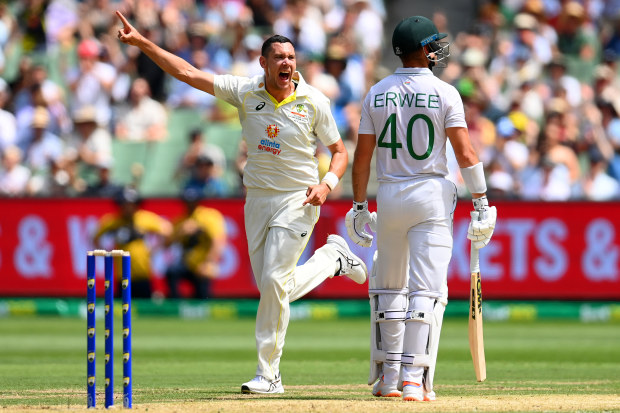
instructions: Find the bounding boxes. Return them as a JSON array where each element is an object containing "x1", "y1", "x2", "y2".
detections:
[{"x1": 375, "y1": 177, "x2": 456, "y2": 301}]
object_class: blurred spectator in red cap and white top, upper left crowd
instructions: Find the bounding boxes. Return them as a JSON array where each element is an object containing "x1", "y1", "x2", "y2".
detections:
[{"x1": 67, "y1": 39, "x2": 116, "y2": 127}]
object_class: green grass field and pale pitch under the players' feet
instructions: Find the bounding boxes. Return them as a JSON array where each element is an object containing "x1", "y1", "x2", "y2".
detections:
[{"x1": 0, "y1": 316, "x2": 620, "y2": 413}]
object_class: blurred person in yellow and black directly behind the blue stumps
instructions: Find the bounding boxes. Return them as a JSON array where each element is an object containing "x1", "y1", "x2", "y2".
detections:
[{"x1": 93, "y1": 187, "x2": 172, "y2": 298}]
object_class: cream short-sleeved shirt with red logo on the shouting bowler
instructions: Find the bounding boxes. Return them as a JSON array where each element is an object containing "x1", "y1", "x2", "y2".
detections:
[{"x1": 214, "y1": 72, "x2": 340, "y2": 191}]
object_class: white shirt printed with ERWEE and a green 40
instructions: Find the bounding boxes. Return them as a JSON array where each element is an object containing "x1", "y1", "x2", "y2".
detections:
[{"x1": 359, "y1": 68, "x2": 467, "y2": 182}]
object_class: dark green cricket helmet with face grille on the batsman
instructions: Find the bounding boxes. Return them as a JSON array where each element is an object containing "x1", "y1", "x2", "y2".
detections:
[{"x1": 392, "y1": 16, "x2": 450, "y2": 64}]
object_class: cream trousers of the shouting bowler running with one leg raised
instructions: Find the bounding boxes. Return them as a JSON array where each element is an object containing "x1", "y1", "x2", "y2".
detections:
[{"x1": 244, "y1": 189, "x2": 338, "y2": 380}]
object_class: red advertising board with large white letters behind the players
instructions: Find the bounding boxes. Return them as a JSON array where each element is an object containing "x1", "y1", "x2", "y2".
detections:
[{"x1": 0, "y1": 199, "x2": 620, "y2": 300}]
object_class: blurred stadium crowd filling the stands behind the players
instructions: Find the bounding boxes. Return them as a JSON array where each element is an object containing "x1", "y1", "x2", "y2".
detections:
[{"x1": 0, "y1": 0, "x2": 620, "y2": 201}]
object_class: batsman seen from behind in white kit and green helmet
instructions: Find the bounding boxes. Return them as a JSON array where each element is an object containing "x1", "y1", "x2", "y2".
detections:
[{"x1": 346, "y1": 16, "x2": 497, "y2": 401}]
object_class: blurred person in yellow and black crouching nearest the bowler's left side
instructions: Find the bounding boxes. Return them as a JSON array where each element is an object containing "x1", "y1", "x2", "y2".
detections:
[{"x1": 166, "y1": 188, "x2": 226, "y2": 299}]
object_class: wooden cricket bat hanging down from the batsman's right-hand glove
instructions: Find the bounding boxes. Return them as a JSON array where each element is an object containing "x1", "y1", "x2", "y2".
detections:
[{"x1": 469, "y1": 243, "x2": 487, "y2": 381}]
